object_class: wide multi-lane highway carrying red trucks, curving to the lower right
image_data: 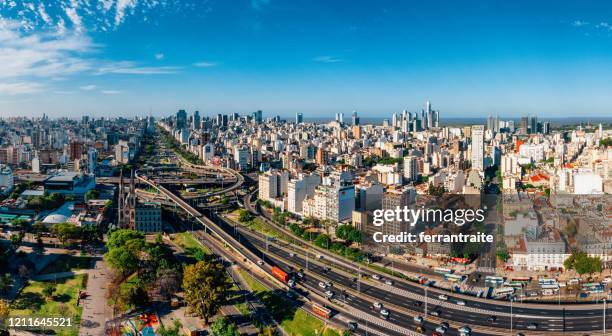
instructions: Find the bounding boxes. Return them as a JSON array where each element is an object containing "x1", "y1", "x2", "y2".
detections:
[{"x1": 135, "y1": 158, "x2": 612, "y2": 335}]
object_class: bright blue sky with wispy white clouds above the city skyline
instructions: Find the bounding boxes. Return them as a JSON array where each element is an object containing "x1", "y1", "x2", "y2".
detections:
[{"x1": 0, "y1": 0, "x2": 612, "y2": 118}]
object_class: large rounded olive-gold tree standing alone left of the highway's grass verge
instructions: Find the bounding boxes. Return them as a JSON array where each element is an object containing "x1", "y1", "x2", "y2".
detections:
[{"x1": 183, "y1": 260, "x2": 229, "y2": 324}]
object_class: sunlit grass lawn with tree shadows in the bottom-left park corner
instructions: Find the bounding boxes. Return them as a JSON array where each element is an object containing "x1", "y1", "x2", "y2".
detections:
[{"x1": 10, "y1": 274, "x2": 87, "y2": 336}]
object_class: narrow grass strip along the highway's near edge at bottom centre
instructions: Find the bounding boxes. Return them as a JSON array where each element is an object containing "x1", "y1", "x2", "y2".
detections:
[{"x1": 239, "y1": 270, "x2": 341, "y2": 336}]
